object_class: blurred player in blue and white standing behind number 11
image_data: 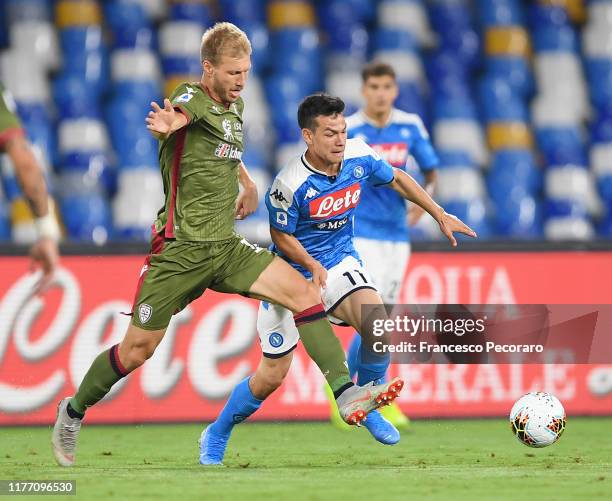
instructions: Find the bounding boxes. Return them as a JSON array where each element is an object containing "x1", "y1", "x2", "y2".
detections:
[{"x1": 331, "y1": 61, "x2": 439, "y2": 428}]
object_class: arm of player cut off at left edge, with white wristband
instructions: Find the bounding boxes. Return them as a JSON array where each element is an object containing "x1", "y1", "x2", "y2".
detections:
[{"x1": 0, "y1": 84, "x2": 60, "y2": 294}]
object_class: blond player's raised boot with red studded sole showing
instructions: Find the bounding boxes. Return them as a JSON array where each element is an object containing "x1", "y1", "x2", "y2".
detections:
[{"x1": 336, "y1": 377, "x2": 404, "y2": 426}]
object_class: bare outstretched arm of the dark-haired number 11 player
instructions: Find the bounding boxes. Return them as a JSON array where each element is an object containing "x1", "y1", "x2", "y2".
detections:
[{"x1": 387, "y1": 169, "x2": 476, "y2": 247}]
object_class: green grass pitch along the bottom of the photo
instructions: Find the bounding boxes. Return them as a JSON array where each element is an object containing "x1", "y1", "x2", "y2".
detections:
[{"x1": 0, "y1": 418, "x2": 612, "y2": 501}]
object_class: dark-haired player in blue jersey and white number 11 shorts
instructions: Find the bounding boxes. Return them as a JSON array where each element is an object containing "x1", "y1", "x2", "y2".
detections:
[{"x1": 200, "y1": 94, "x2": 476, "y2": 464}]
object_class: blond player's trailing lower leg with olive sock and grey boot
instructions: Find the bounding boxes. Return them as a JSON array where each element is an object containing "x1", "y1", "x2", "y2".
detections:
[{"x1": 51, "y1": 325, "x2": 166, "y2": 466}]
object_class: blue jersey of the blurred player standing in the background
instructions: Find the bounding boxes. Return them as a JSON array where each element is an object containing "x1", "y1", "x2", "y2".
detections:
[{"x1": 346, "y1": 109, "x2": 439, "y2": 242}]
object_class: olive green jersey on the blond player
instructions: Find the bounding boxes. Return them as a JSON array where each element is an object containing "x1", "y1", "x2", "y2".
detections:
[{"x1": 155, "y1": 83, "x2": 244, "y2": 242}]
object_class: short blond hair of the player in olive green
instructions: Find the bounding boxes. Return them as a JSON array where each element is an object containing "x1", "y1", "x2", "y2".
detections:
[{"x1": 200, "y1": 23, "x2": 252, "y2": 65}]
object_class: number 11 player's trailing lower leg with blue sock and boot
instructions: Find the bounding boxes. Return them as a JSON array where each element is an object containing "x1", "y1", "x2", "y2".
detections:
[{"x1": 199, "y1": 352, "x2": 293, "y2": 465}]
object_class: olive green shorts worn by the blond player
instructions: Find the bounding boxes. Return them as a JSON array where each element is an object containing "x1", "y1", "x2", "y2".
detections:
[{"x1": 132, "y1": 235, "x2": 274, "y2": 330}]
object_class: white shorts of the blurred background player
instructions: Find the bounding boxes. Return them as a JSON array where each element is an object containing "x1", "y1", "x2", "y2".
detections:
[{"x1": 353, "y1": 238, "x2": 410, "y2": 304}]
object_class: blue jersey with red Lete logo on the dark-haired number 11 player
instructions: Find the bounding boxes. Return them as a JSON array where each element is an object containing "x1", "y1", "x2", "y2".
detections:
[{"x1": 266, "y1": 139, "x2": 394, "y2": 278}]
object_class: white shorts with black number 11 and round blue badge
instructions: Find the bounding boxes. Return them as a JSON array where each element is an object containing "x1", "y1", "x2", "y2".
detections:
[{"x1": 257, "y1": 256, "x2": 376, "y2": 358}]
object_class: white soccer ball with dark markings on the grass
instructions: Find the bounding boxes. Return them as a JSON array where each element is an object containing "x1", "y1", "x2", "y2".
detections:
[{"x1": 510, "y1": 391, "x2": 565, "y2": 447}]
